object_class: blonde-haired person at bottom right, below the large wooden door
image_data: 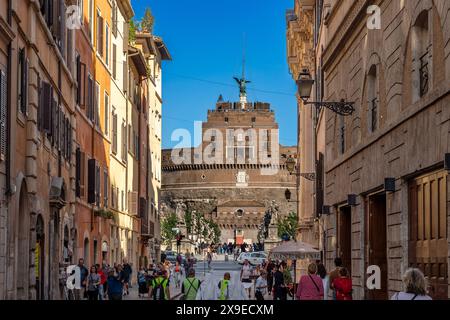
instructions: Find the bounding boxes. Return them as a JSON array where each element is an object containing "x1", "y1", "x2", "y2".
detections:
[{"x1": 391, "y1": 268, "x2": 433, "y2": 300}]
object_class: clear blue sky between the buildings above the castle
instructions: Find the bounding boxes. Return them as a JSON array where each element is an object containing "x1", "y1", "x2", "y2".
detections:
[{"x1": 131, "y1": 0, "x2": 297, "y2": 148}]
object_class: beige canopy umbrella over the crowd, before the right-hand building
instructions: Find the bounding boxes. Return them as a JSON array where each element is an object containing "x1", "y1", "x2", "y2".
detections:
[{"x1": 269, "y1": 241, "x2": 320, "y2": 260}]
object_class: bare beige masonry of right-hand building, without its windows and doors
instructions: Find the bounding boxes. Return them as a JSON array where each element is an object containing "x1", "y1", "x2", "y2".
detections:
[{"x1": 322, "y1": 1, "x2": 450, "y2": 298}]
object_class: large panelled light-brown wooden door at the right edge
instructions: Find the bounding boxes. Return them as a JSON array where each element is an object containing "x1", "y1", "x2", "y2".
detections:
[{"x1": 409, "y1": 171, "x2": 448, "y2": 299}]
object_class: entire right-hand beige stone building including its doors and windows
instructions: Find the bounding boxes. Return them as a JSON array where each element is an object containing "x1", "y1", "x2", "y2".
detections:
[{"x1": 291, "y1": 0, "x2": 450, "y2": 299}]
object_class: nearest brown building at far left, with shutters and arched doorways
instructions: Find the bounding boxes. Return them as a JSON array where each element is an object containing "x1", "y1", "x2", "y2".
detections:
[{"x1": 0, "y1": 0, "x2": 75, "y2": 299}]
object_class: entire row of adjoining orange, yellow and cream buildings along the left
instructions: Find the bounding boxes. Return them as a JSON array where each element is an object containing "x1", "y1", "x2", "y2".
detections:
[{"x1": 0, "y1": 0, "x2": 170, "y2": 300}]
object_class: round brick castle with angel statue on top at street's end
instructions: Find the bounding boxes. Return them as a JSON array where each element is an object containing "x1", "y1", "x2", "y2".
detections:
[{"x1": 161, "y1": 78, "x2": 297, "y2": 244}]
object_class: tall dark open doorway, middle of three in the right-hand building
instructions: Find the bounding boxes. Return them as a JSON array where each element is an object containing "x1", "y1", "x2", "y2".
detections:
[{"x1": 365, "y1": 194, "x2": 388, "y2": 300}]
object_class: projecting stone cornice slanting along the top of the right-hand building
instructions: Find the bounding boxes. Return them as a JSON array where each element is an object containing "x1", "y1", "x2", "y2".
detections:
[{"x1": 322, "y1": 0, "x2": 370, "y2": 70}]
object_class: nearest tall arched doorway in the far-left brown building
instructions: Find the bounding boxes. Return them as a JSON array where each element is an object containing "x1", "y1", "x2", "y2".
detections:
[{"x1": 16, "y1": 183, "x2": 31, "y2": 300}]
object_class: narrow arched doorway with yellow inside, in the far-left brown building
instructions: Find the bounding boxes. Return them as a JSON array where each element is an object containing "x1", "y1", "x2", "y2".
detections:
[{"x1": 34, "y1": 215, "x2": 45, "y2": 300}]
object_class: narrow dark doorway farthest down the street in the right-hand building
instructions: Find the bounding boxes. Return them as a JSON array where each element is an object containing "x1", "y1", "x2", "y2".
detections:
[{"x1": 338, "y1": 206, "x2": 352, "y2": 274}]
